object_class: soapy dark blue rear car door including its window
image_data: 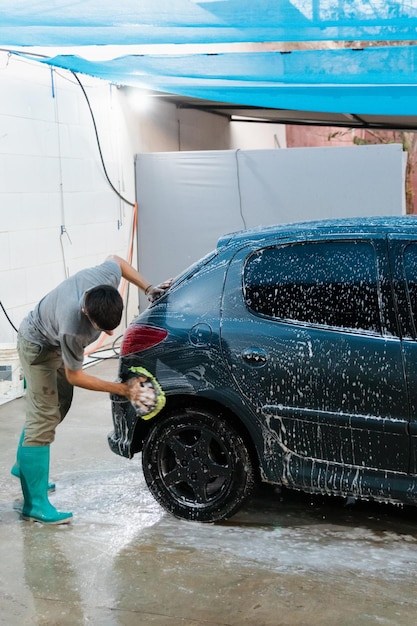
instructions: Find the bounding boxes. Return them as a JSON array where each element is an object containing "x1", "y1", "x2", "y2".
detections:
[{"x1": 221, "y1": 235, "x2": 409, "y2": 472}]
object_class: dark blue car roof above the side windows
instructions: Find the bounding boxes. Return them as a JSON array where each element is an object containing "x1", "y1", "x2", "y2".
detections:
[{"x1": 217, "y1": 215, "x2": 417, "y2": 248}]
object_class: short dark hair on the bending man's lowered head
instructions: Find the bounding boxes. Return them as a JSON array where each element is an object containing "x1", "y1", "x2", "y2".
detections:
[{"x1": 84, "y1": 285, "x2": 123, "y2": 330}]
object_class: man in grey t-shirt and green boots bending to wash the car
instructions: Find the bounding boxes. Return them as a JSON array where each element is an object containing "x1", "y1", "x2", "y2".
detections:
[{"x1": 11, "y1": 255, "x2": 171, "y2": 524}]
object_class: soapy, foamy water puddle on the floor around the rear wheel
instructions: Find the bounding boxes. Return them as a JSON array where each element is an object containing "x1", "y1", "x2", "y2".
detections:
[{"x1": 4, "y1": 456, "x2": 417, "y2": 578}]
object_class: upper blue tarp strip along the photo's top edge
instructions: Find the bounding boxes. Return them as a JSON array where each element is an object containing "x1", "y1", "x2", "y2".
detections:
[{"x1": 0, "y1": 0, "x2": 417, "y2": 46}]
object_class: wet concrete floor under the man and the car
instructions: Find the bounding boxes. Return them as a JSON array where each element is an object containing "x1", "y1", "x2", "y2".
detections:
[{"x1": 0, "y1": 360, "x2": 417, "y2": 626}]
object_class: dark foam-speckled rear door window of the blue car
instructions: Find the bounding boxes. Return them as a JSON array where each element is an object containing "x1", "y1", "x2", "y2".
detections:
[{"x1": 244, "y1": 241, "x2": 381, "y2": 333}]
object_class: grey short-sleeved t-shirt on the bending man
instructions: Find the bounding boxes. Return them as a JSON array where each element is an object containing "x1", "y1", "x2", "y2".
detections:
[{"x1": 19, "y1": 260, "x2": 122, "y2": 370}]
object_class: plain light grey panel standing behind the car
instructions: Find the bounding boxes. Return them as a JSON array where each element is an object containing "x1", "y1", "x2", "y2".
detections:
[{"x1": 136, "y1": 144, "x2": 405, "y2": 306}]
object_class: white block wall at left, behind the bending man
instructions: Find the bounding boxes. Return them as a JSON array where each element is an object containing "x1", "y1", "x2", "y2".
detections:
[{"x1": 0, "y1": 53, "x2": 135, "y2": 342}]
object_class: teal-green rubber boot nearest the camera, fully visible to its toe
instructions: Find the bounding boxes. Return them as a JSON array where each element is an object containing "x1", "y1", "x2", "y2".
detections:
[{"x1": 19, "y1": 446, "x2": 72, "y2": 524}]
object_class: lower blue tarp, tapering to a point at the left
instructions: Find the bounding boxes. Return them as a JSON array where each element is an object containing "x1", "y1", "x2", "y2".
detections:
[{"x1": 30, "y1": 46, "x2": 417, "y2": 115}]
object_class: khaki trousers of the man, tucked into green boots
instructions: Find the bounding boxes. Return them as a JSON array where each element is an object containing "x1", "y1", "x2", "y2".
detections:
[{"x1": 17, "y1": 333, "x2": 73, "y2": 446}]
